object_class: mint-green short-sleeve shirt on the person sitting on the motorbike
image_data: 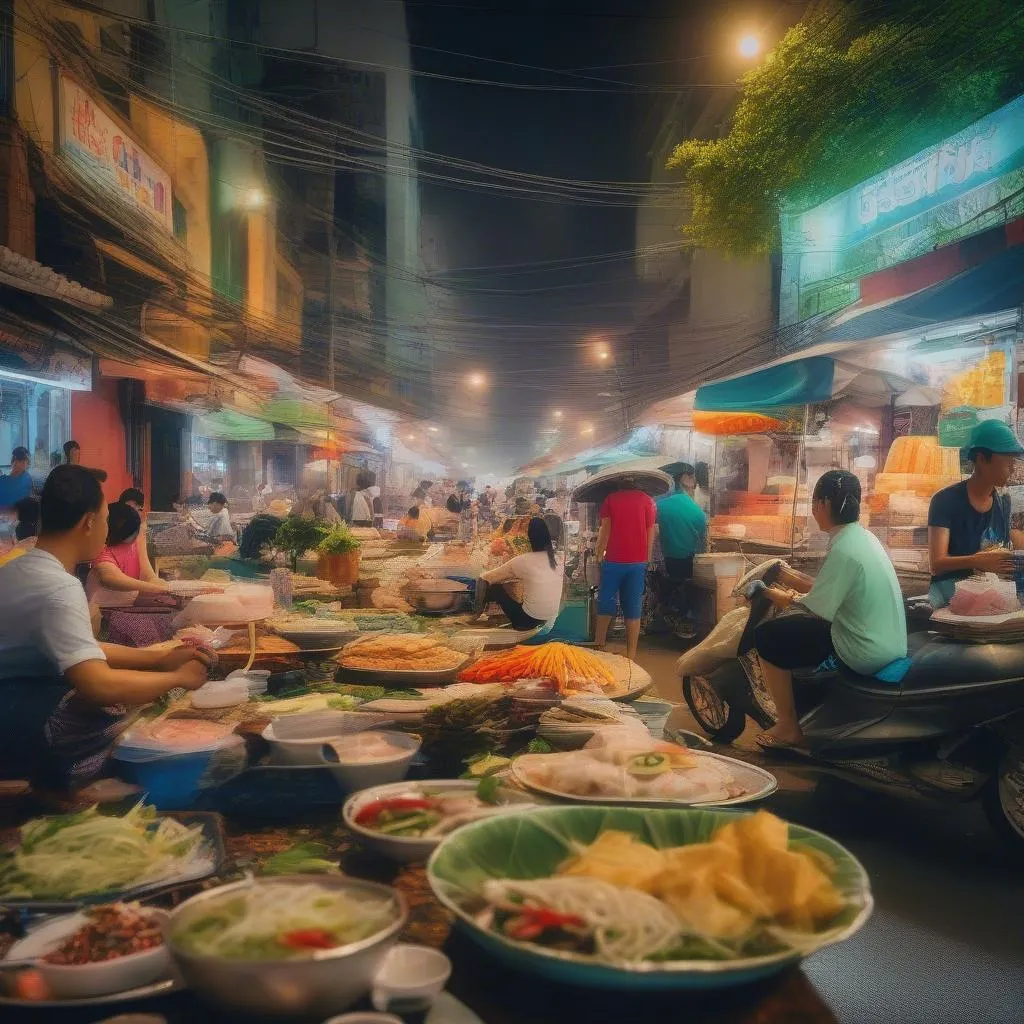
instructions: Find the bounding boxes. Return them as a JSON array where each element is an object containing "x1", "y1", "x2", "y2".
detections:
[{"x1": 800, "y1": 522, "x2": 906, "y2": 676}]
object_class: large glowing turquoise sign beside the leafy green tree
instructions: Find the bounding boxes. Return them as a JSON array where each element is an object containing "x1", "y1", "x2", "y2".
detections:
[{"x1": 779, "y1": 96, "x2": 1024, "y2": 326}]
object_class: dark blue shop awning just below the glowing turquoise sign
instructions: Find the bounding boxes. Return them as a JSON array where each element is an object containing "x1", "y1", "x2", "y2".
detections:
[{"x1": 819, "y1": 246, "x2": 1024, "y2": 348}]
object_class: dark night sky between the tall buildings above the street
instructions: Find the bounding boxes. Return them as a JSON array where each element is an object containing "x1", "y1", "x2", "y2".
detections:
[{"x1": 406, "y1": 0, "x2": 787, "y2": 471}]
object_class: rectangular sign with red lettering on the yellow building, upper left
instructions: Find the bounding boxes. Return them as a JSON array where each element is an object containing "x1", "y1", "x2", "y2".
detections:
[{"x1": 59, "y1": 73, "x2": 174, "y2": 232}]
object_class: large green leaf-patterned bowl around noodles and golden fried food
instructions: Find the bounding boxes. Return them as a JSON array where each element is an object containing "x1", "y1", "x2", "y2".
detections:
[{"x1": 427, "y1": 807, "x2": 873, "y2": 989}]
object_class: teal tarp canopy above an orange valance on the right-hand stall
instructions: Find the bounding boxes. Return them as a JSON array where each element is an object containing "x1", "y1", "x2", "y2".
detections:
[{"x1": 693, "y1": 355, "x2": 836, "y2": 413}]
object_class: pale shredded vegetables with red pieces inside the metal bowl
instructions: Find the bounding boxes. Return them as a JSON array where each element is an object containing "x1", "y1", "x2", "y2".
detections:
[{"x1": 173, "y1": 884, "x2": 397, "y2": 961}]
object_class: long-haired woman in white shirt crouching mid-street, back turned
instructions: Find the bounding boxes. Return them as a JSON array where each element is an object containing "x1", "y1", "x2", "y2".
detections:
[{"x1": 476, "y1": 518, "x2": 563, "y2": 631}]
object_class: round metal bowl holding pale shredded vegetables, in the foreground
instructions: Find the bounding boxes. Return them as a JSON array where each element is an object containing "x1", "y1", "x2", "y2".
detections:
[{"x1": 164, "y1": 874, "x2": 409, "y2": 1019}]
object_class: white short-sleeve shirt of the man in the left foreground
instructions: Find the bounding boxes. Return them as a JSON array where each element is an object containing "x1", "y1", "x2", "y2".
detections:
[{"x1": 0, "y1": 548, "x2": 106, "y2": 679}]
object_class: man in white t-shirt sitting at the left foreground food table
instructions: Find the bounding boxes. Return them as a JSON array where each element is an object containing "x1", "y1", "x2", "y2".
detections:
[{"x1": 0, "y1": 465, "x2": 208, "y2": 796}]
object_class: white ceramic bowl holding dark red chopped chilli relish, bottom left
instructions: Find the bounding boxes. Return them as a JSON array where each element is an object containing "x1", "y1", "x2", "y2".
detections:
[{"x1": 6, "y1": 907, "x2": 171, "y2": 999}]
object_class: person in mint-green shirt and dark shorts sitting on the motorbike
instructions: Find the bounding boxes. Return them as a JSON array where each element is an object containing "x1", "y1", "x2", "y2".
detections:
[{"x1": 754, "y1": 469, "x2": 906, "y2": 750}]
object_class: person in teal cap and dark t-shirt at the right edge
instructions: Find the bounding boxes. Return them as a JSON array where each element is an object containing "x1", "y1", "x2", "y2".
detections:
[{"x1": 928, "y1": 420, "x2": 1024, "y2": 608}]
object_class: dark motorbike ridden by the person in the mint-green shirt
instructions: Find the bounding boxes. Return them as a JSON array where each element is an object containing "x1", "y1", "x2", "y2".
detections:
[{"x1": 680, "y1": 562, "x2": 1024, "y2": 853}]
